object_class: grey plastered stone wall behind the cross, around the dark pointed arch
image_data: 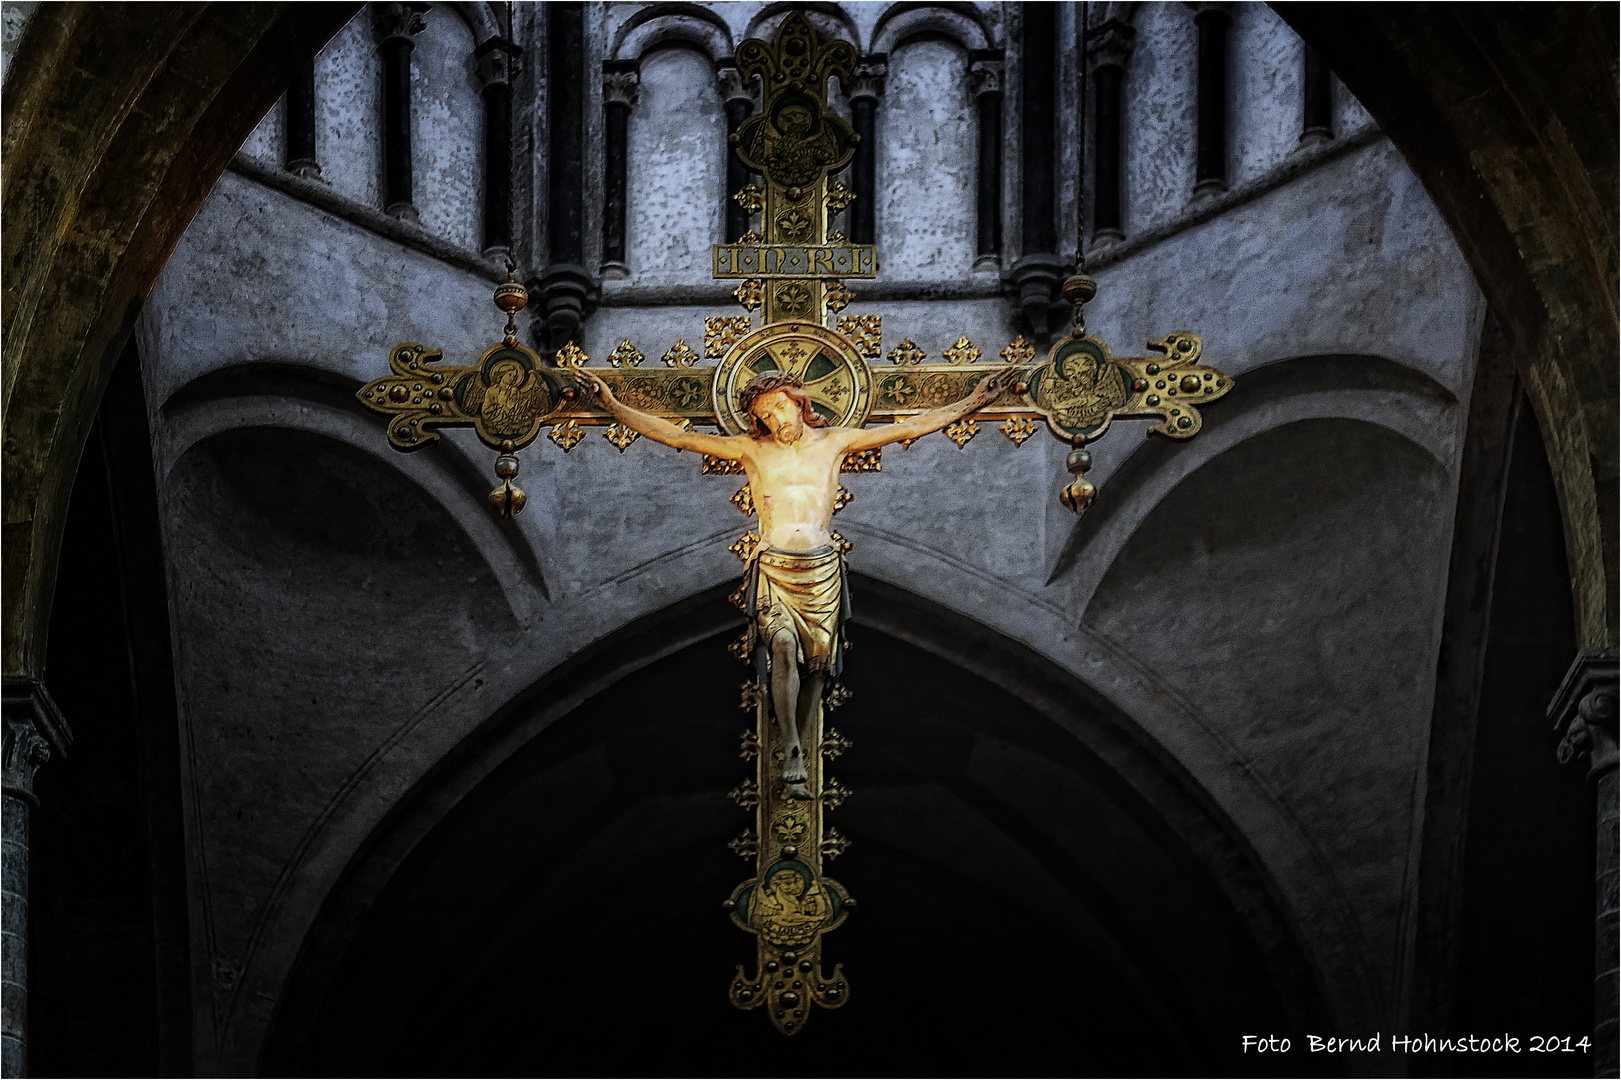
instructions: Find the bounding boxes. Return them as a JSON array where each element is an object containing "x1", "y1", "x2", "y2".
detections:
[{"x1": 138, "y1": 3, "x2": 1483, "y2": 1075}]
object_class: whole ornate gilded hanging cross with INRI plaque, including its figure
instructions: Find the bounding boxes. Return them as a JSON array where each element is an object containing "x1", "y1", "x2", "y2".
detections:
[{"x1": 357, "y1": 11, "x2": 1232, "y2": 1035}]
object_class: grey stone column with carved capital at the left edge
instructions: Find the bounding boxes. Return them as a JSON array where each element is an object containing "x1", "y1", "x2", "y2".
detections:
[{"x1": 0, "y1": 679, "x2": 73, "y2": 1077}]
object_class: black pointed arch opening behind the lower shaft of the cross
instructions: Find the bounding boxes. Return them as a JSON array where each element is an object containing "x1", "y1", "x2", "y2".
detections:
[{"x1": 267, "y1": 581, "x2": 1323, "y2": 1075}]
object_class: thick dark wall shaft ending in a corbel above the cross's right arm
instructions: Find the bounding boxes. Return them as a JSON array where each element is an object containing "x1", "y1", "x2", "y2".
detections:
[{"x1": 1007, "y1": 3, "x2": 1075, "y2": 342}]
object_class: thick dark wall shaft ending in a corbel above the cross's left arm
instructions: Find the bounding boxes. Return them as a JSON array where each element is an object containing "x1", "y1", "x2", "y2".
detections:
[{"x1": 530, "y1": 0, "x2": 597, "y2": 352}]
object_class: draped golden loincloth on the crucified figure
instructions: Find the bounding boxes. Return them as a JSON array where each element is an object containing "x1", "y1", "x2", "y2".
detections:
[{"x1": 746, "y1": 548, "x2": 849, "y2": 676}]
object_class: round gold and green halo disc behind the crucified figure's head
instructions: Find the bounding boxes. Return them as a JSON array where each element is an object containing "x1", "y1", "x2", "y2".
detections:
[{"x1": 713, "y1": 323, "x2": 872, "y2": 435}]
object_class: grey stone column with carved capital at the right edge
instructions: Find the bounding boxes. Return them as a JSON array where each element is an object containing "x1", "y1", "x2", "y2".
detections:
[{"x1": 1548, "y1": 649, "x2": 1621, "y2": 1077}]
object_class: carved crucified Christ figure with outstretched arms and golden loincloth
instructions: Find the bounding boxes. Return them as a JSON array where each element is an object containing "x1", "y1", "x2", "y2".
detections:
[{"x1": 575, "y1": 368, "x2": 1012, "y2": 799}]
